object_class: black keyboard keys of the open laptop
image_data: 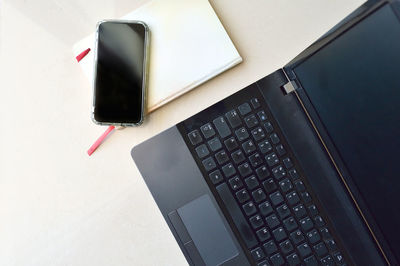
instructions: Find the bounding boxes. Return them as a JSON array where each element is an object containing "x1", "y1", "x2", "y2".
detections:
[{"x1": 187, "y1": 98, "x2": 345, "y2": 266}]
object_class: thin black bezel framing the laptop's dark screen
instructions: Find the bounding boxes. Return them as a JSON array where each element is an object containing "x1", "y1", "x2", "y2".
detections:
[{"x1": 283, "y1": 0, "x2": 400, "y2": 263}]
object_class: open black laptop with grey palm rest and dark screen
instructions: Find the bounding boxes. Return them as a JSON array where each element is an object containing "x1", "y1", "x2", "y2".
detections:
[{"x1": 131, "y1": 1, "x2": 400, "y2": 266}]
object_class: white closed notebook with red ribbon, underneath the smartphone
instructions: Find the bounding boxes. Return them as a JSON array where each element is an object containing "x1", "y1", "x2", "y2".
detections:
[{"x1": 73, "y1": 0, "x2": 242, "y2": 112}]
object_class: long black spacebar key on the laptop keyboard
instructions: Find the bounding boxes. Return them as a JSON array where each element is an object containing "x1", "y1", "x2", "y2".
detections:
[{"x1": 217, "y1": 183, "x2": 258, "y2": 249}]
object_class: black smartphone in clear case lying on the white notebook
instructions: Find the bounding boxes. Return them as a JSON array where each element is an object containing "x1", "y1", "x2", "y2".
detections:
[{"x1": 92, "y1": 20, "x2": 149, "y2": 126}]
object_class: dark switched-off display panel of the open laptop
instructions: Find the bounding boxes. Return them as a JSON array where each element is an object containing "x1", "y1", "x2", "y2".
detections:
[{"x1": 294, "y1": 5, "x2": 400, "y2": 260}]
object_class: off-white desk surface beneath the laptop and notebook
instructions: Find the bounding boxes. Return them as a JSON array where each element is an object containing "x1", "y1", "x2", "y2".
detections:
[{"x1": 0, "y1": 0, "x2": 363, "y2": 266}]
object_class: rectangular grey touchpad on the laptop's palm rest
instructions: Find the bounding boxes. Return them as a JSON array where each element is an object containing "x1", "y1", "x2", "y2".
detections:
[{"x1": 177, "y1": 194, "x2": 239, "y2": 265}]
